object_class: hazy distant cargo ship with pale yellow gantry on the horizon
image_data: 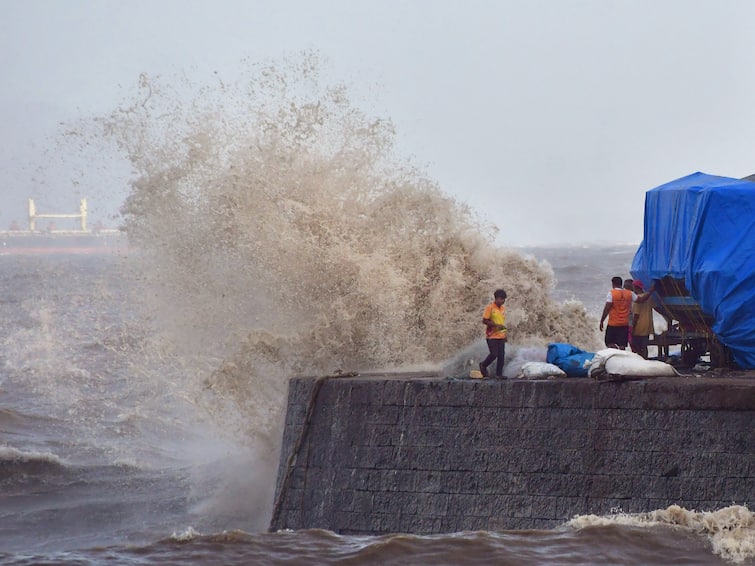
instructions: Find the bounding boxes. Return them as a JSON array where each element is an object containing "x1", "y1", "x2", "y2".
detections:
[{"x1": 0, "y1": 198, "x2": 127, "y2": 255}]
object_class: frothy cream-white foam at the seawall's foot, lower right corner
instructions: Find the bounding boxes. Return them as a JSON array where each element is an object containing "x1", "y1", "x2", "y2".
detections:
[{"x1": 568, "y1": 505, "x2": 755, "y2": 564}]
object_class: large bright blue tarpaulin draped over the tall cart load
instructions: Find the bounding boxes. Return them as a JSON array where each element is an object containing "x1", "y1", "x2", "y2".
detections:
[{"x1": 631, "y1": 173, "x2": 755, "y2": 369}]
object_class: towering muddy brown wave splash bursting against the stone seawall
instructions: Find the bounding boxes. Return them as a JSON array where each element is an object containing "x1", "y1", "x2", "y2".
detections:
[{"x1": 74, "y1": 54, "x2": 596, "y2": 482}]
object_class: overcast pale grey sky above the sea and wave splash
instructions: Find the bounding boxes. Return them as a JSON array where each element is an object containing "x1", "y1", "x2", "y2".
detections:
[{"x1": 0, "y1": 0, "x2": 755, "y2": 245}]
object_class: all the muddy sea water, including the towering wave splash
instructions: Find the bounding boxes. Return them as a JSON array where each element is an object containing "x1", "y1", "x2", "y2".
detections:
[{"x1": 0, "y1": 56, "x2": 755, "y2": 565}]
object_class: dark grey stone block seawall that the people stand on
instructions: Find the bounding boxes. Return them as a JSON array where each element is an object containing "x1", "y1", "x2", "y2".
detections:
[{"x1": 270, "y1": 374, "x2": 755, "y2": 534}]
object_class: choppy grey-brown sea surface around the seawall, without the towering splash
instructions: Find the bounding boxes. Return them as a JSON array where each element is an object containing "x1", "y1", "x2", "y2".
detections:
[{"x1": 0, "y1": 250, "x2": 755, "y2": 565}]
